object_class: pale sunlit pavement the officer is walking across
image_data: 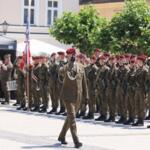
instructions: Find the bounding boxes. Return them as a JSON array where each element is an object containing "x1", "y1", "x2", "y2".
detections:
[{"x1": 0, "y1": 102, "x2": 150, "y2": 150}]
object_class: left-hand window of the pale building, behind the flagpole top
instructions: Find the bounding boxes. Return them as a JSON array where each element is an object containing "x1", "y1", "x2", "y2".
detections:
[{"x1": 23, "y1": 0, "x2": 35, "y2": 25}]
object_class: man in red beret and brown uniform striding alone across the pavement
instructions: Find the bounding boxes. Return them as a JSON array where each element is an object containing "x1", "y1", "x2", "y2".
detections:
[{"x1": 58, "y1": 48, "x2": 89, "y2": 148}]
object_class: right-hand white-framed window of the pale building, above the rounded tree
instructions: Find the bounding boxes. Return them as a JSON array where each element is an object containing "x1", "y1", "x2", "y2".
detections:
[{"x1": 47, "y1": 0, "x2": 58, "y2": 26}]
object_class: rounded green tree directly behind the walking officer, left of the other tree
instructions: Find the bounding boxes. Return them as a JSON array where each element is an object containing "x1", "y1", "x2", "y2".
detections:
[{"x1": 50, "y1": 6, "x2": 107, "y2": 55}]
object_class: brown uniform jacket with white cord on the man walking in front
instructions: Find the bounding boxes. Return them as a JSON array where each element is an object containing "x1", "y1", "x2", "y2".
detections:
[{"x1": 60, "y1": 63, "x2": 89, "y2": 102}]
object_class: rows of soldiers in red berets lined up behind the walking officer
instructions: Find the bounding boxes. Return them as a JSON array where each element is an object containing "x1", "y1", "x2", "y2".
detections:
[{"x1": 1, "y1": 49, "x2": 150, "y2": 126}]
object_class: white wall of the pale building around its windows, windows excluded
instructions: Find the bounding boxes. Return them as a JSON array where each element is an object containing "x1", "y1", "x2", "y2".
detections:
[{"x1": 0, "y1": 0, "x2": 79, "y2": 47}]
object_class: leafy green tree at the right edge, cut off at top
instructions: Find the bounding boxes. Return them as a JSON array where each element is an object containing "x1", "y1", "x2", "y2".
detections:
[{"x1": 99, "y1": 0, "x2": 150, "y2": 53}]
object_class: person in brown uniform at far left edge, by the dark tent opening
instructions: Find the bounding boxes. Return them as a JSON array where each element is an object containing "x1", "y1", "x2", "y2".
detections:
[{"x1": 0, "y1": 54, "x2": 13, "y2": 104}]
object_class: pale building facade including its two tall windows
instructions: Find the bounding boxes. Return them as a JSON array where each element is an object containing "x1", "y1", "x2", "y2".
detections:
[{"x1": 0, "y1": 0, "x2": 79, "y2": 46}]
